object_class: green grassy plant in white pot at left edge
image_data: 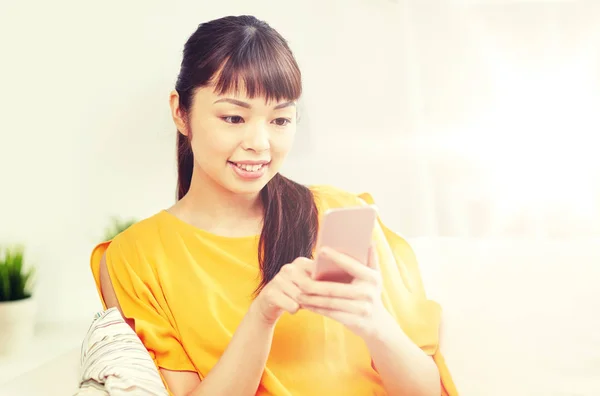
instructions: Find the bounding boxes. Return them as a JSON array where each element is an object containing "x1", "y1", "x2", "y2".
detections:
[{"x1": 0, "y1": 246, "x2": 36, "y2": 354}]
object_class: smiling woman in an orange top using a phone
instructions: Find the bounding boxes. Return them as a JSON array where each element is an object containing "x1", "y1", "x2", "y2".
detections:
[{"x1": 92, "y1": 16, "x2": 456, "y2": 396}]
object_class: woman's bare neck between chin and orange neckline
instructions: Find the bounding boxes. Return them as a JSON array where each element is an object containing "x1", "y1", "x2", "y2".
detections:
[{"x1": 172, "y1": 168, "x2": 263, "y2": 235}]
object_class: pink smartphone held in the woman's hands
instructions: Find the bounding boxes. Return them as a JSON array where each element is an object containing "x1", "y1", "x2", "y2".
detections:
[{"x1": 313, "y1": 206, "x2": 377, "y2": 283}]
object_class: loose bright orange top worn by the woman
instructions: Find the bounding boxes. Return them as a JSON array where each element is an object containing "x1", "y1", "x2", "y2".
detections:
[{"x1": 91, "y1": 186, "x2": 457, "y2": 396}]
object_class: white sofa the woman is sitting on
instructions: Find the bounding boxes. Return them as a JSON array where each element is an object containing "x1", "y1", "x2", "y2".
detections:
[{"x1": 0, "y1": 238, "x2": 600, "y2": 396}]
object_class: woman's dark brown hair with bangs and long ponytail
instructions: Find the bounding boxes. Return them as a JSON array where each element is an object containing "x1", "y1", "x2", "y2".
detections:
[{"x1": 175, "y1": 15, "x2": 318, "y2": 291}]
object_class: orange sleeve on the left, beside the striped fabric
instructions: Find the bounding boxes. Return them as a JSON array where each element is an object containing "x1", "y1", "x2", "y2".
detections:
[{"x1": 92, "y1": 234, "x2": 196, "y2": 371}]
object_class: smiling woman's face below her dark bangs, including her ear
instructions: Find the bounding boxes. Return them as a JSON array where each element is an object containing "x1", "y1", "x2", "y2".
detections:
[{"x1": 171, "y1": 87, "x2": 296, "y2": 194}]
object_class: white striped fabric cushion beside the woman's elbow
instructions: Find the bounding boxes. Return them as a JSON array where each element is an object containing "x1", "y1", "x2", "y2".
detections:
[{"x1": 74, "y1": 308, "x2": 168, "y2": 396}]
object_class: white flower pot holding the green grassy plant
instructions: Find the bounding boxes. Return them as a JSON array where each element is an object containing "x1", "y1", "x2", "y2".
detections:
[{"x1": 0, "y1": 298, "x2": 37, "y2": 355}]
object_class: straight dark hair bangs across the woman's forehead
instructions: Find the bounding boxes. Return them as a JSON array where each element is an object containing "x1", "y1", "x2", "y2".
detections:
[{"x1": 214, "y1": 31, "x2": 302, "y2": 102}]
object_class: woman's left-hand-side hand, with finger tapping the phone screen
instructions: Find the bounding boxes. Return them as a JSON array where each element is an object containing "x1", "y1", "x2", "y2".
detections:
[{"x1": 251, "y1": 257, "x2": 315, "y2": 325}]
